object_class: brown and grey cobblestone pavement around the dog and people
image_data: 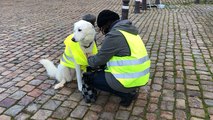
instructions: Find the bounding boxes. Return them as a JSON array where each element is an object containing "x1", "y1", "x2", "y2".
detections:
[{"x1": 0, "y1": 0, "x2": 213, "y2": 120}]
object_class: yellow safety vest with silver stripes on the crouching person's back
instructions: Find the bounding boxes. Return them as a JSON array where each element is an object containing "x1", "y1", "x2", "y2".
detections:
[{"x1": 105, "y1": 30, "x2": 151, "y2": 88}]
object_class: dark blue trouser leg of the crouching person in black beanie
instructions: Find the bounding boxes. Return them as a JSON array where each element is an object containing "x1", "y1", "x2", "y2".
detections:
[{"x1": 91, "y1": 70, "x2": 131, "y2": 98}]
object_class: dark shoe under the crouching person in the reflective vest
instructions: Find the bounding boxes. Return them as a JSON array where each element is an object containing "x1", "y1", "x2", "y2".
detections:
[{"x1": 120, "y1": 92, "x2": 138, "y2": 107}]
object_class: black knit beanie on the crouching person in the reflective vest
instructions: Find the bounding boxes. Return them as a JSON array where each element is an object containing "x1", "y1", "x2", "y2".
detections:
[{"x1": 97, "y1": 10, "x2": 120, "y2": 28}]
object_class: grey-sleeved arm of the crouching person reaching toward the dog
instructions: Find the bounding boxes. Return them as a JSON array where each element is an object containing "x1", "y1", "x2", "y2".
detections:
[{"x1": 88, "y1": 32, "x2": 129, "y2": 67}]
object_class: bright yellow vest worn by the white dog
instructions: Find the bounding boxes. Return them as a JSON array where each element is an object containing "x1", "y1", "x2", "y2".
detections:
[{"x1": 60, "y1": 34, "x2": 98, "y2": 71}]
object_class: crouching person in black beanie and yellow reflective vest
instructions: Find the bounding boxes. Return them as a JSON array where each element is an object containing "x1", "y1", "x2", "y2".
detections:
[{"x1": 88, "y1": 10, "x2": 150, "y2": 107}]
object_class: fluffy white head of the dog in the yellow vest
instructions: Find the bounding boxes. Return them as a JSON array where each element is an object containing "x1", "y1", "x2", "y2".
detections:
[{"x1": 72, "y1": 20, "x2": 96, "y2": 44}]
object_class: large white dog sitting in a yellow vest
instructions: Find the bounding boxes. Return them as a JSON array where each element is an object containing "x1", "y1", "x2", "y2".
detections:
[{"x1": 39, "y1": 20, "x2": 97, "y2": 91}]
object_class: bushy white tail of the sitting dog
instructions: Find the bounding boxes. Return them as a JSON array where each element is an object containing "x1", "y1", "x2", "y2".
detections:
[{"x1": 39, "y1": 59, "x2": 57, "y2": 78}]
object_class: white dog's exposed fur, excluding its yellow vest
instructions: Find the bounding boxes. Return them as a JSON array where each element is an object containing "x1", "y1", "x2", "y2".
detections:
[{"x1": 39, "y1": 20, "x2": 96, "y2": 91}]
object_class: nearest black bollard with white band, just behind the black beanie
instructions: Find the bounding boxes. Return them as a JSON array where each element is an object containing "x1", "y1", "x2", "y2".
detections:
[{"x1": 121, "y1": 0, "x2": 129, "y2": 20}]
